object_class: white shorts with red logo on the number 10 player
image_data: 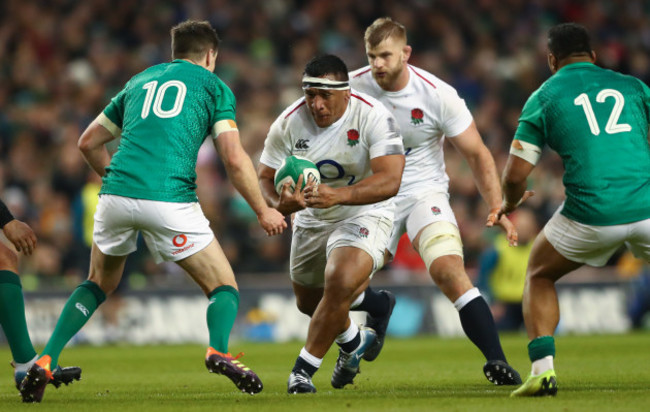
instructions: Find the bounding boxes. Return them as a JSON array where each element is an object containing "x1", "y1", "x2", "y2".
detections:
[{"x1": 93, "y1": 195, "x2": 214, "y2": 263}]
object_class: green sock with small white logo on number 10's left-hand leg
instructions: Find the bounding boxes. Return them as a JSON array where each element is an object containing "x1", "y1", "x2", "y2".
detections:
[{"x1": 41, "y1": 280, "x2": 106, "y2": 370}]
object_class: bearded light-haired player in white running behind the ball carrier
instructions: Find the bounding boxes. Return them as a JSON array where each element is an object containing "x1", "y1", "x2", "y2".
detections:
[{"x1": 350, "y1": 18, "x2": 521, "y2": 385}]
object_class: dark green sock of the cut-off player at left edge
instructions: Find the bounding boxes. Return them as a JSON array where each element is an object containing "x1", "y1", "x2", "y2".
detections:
[{"x1": 0, "y1": 270, "x2": 36, "y2": 363}]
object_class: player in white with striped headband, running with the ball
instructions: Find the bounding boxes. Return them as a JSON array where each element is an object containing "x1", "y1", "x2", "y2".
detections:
[{"x1": 258, "y1": 55, "x2": 404, "y2": 393}]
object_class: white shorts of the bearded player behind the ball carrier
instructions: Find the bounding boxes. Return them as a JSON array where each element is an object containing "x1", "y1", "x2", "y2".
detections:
[{"x1": 388, "y1": 191, "x2": 458, "y2": 256}]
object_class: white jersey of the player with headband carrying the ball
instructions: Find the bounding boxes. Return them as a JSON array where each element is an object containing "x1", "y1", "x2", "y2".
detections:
[{"x1": 260, "y1": 90, "x2": 404, "y2": 227}]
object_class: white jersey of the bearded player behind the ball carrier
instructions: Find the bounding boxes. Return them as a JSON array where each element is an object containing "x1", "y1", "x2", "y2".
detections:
[{"x1": 350, "y1": 65, "x2": 472, "y2": 196}]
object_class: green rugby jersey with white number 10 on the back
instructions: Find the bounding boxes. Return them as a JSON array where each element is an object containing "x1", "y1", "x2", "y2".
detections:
[{"x1": 100, "y1": 60, "x2": 235, "y2": 202}]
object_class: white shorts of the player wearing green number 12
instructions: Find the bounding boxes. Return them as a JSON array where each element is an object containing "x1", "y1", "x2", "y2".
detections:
[{"x1": 544, "y1": 204, "x2": 650, "y2": 267}]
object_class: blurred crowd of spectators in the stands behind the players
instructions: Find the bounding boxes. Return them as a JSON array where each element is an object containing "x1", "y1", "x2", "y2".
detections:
[{"x1": 0, "y1": 0, "x2": 650, "y2": 289}]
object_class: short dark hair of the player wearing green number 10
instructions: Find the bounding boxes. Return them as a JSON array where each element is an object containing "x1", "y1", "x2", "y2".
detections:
[{"x1": 171, "y1": 20, "x2": 221, "y2": 59}]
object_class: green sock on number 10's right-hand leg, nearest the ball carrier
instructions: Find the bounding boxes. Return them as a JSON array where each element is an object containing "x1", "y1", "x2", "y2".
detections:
[{"x1": 207, "y1": 286, "x2": 239, "y2": 353}]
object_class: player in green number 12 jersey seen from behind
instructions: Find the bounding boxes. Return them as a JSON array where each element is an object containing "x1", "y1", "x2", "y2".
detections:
[{"x1": 499, "y1": 23, "x2": 650, "y2": 396}]
